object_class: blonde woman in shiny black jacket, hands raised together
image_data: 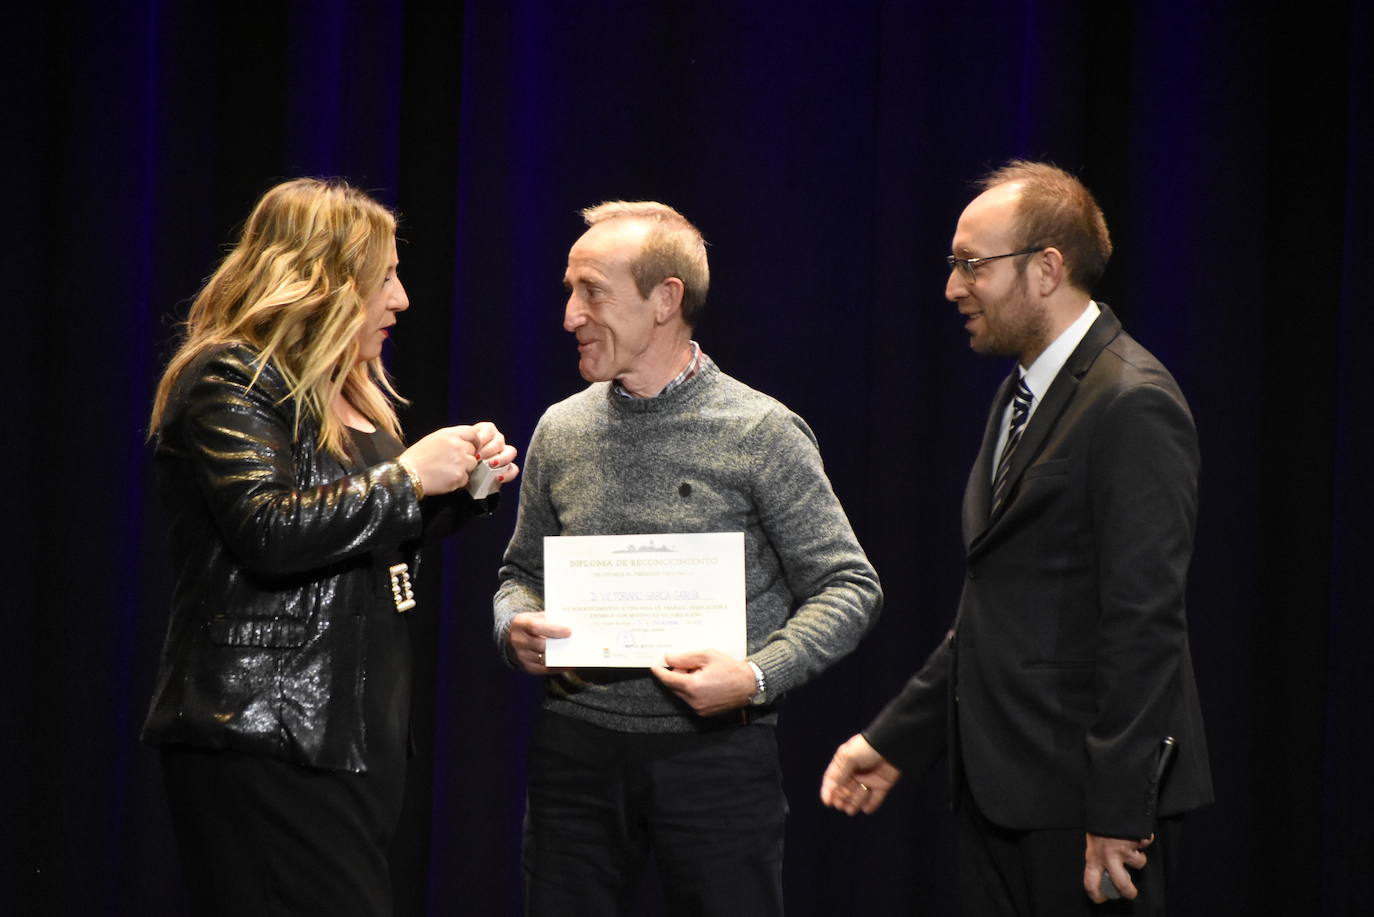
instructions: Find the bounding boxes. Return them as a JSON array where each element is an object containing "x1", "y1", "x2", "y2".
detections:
[{"x1": 143, "y1": 179, "x2": 519, "y2": 917}]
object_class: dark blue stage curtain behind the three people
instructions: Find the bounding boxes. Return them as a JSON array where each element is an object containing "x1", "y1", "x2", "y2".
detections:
[{"x1": 0, "y1": 0, "x2": 1374, "y2": 917}]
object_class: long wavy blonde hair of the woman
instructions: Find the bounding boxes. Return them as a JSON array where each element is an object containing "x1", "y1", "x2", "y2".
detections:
[{"x1": 148, "y1": 179, "x2": 404, "y2": 459}]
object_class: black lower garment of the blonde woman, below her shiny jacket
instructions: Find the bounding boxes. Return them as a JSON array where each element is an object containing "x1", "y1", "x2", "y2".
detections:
[{"x1": 162, "y1": 745, "x2": 404, "y2": 917}]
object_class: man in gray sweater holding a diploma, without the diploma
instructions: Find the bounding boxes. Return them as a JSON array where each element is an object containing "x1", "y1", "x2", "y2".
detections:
[{"x1": 495, "y1": 202, "x2": 881, "y2": 916}]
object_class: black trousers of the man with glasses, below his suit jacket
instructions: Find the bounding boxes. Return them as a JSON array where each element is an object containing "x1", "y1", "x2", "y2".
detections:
[{"x1": 956, "y1": 786, "x2": 1183, "y2": 917}]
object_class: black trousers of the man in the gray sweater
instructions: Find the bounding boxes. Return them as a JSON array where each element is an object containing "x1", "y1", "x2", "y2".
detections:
[{"x1": 523, "y1": 714, "x2": 787, "y2": 917}]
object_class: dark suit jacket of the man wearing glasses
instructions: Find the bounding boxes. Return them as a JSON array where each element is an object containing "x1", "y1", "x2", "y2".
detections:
[{"x1": 864, "y1": 308, "x2": 1212, "y2": 837}]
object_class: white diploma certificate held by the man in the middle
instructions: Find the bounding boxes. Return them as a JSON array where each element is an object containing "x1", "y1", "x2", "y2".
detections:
[{"x1": 544, "y1": 532, "x2": 746, "y2": 668}]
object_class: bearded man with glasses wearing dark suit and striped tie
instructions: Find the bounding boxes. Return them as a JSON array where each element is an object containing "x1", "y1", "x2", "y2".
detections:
[{"x1": 822, "y1": 162, "x2": 1212, "y2": 914}]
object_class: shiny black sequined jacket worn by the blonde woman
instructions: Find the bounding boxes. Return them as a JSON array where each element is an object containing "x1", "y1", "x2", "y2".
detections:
[{"x1": 143, "y1": 345, "x2": 491, "y2": 771}]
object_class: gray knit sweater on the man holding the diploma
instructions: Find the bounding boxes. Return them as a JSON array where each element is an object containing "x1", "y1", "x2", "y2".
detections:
[{"x1": 495, "y1": 359, "x2": 882, "y2": 733}]
